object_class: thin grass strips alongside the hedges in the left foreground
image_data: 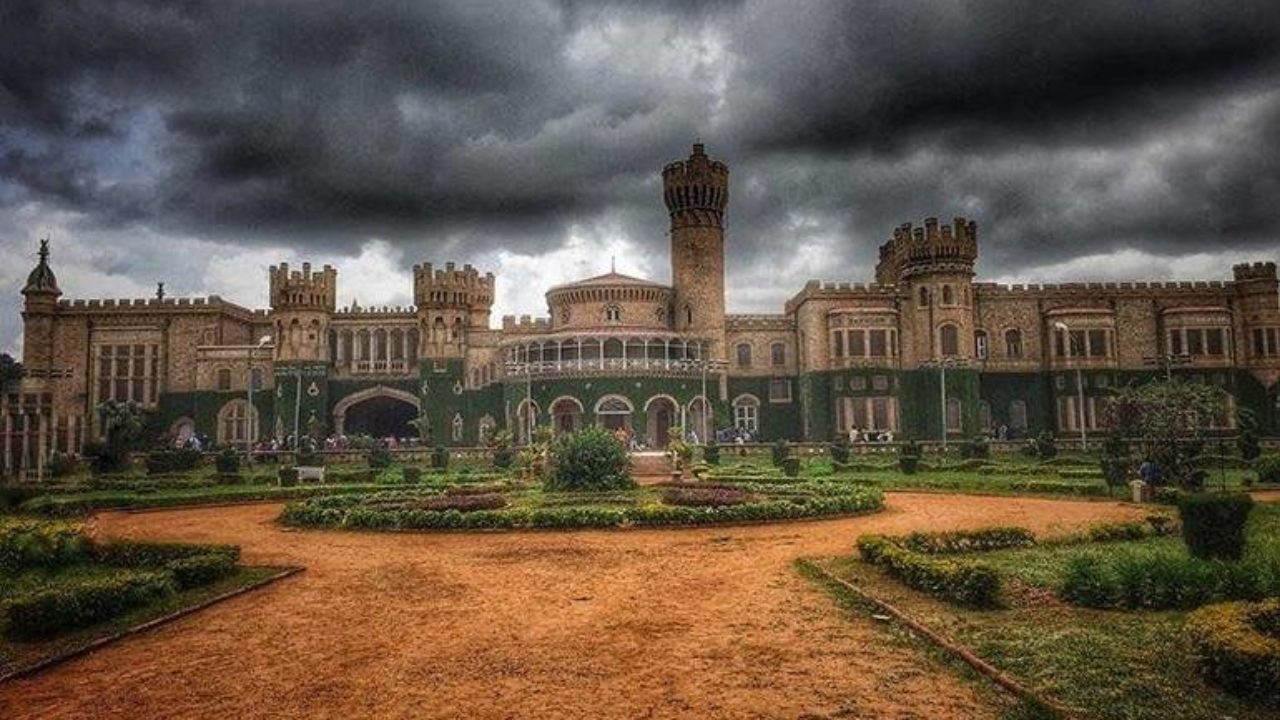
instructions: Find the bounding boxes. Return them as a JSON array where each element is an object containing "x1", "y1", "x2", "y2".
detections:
[{"x1": 0, "y1": 565, "x2": 283, "y2": 675}]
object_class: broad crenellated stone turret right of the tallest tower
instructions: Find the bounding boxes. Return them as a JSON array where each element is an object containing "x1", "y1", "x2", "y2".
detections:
[{"x1": 876, "y1": 218, "x2": 978, "y2": 361}]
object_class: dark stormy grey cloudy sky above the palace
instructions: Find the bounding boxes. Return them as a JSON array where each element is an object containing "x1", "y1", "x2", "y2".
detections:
[{"x1": 0, "y1": 0, "x2": 1280, "y2": 351}]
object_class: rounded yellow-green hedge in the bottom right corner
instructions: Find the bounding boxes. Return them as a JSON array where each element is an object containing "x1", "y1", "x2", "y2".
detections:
[{"x1": 1187, "y1": 598, "x2": 1280, "y2": 705}]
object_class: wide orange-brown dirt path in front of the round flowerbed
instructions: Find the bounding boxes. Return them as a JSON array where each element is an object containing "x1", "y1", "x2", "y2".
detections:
[{"x1": 0, "y1": 493, "x2": 1140, "y2": 720}]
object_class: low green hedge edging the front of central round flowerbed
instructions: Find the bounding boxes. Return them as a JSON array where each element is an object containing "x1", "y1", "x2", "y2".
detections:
[{"x1": 280, "y1": 488, "x2": 884, "y2": 530}]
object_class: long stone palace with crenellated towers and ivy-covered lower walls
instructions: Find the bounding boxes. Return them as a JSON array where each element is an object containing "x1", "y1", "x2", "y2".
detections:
[{"x1": 0, "y1": 145, "x2": 1280, "y2": 475}]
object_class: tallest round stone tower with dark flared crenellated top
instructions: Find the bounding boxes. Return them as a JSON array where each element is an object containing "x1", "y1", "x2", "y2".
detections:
[{"x1": 662, "y1": 143, "x2": 728, "y2": 359}]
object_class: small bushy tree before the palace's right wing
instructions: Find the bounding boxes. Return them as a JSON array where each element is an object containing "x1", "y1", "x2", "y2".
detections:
[{"x1": 1107, "y1": 379, "x2": 1224, "y2": 486}]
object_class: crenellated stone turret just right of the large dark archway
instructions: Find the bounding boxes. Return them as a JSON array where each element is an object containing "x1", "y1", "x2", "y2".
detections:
[{"x1": 413, "y1": 263, "x2": 493, "y2": 357}]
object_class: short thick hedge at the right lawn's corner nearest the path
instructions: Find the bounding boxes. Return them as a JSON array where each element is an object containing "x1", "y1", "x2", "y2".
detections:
[{"x1": 858, "y1": 536, "x2": 1000, "y2": 607}]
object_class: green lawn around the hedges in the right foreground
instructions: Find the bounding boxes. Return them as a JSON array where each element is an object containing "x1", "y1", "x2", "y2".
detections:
[{"x1": 819, "y1": 505, "x2": 1280, "y2": 720}]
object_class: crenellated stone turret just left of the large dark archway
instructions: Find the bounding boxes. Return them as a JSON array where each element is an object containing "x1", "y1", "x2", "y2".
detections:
[{"x1": 269, "y1": 263, "x2": 338, "y2": 363}]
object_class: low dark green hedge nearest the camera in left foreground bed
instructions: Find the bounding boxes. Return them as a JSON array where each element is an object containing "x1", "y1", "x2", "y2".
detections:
[{"x1": 5, "y1": 573, "x2": 174, "y2": 639}]
